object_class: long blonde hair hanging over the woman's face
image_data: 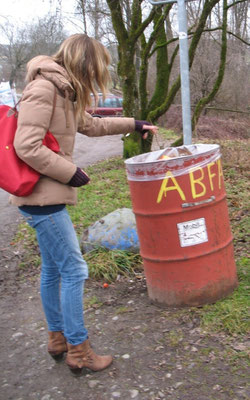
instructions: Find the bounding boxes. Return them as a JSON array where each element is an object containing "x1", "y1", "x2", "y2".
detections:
[{"x1": 52, "y1": 34, "x2": 111, "y2": 121}]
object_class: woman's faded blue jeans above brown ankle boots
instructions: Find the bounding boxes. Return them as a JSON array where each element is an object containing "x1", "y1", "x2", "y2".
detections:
[{"x1": 21, "y1": 208, "x2": 88, "y2": 345}]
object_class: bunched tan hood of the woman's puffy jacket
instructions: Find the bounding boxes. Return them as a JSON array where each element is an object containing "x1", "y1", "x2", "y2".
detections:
[{"x1": 26, "y1": 56, "x2": 76, "y2": 101}]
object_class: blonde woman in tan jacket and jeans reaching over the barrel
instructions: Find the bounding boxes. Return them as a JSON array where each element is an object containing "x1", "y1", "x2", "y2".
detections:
[{"x1": 11, "y1": 34, "x2": 157, "y2": 373}]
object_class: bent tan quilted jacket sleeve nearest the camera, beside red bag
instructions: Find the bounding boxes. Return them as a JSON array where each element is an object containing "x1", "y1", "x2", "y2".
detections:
[{"x1": 14, "y1": 79, "x2": 76, "y2": 183}]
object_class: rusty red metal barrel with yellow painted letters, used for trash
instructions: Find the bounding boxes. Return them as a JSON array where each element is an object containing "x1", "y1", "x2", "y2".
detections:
[{"x1": 125, "y1": 144, "x2": 237, "y2": 306}]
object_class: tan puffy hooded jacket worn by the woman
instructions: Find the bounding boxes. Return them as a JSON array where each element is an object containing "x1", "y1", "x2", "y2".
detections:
[{"x1": 10, "y1": 56, "x2": 135, "y2": 206}]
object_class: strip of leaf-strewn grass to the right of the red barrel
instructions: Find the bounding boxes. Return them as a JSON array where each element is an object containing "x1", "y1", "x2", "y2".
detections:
[{"x1": 197, "y1": 141, "x2": 250, "y2": 335}]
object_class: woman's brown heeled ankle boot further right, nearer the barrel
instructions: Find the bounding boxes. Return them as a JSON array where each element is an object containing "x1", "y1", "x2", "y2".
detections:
[{"x1": 66, "y1": 339, "x2": 113, "y2": 375}]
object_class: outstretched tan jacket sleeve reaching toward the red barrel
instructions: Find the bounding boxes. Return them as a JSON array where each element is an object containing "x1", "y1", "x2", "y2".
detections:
[{"x1": 77, "y1": 112, "x2": 135, "y2": 136}]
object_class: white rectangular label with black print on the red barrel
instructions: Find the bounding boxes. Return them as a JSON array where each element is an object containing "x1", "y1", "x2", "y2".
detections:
[{"x1": 177, "y1": 218, "x2": 208, "y2": 247}]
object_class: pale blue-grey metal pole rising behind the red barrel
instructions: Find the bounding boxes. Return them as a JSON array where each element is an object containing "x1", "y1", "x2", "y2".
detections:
[{"x1": 148, "y1": 0, "x2": 192, "y2": 145}]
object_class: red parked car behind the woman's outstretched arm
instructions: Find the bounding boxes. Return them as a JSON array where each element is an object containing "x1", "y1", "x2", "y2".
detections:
[{"x1": 87, "y1": 93, "x2": 123, "y2": 117}]
